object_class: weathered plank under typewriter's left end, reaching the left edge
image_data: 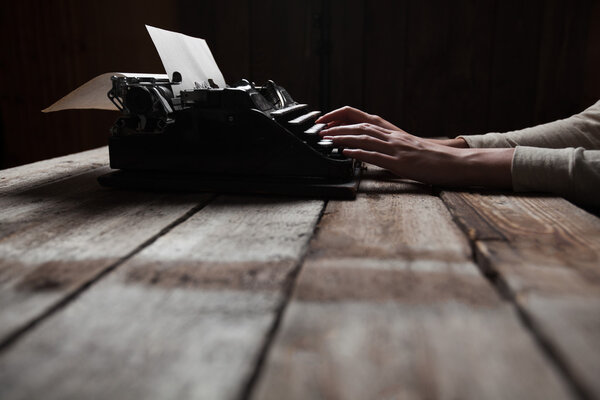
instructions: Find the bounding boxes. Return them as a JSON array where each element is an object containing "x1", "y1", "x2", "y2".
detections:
[{"x1": 0, "y1": 169, "x2": 210, "y2": 342}]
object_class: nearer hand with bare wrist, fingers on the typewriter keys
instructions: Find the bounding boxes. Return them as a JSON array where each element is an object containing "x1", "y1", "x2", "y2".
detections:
[{"x1": 320, "y1": 123, "x2": 514, "y2": 188}]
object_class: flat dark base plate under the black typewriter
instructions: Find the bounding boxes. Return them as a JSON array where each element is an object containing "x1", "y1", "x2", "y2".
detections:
[{"x1": 98, "y1": 168, "x2": 360, "y2": 200}]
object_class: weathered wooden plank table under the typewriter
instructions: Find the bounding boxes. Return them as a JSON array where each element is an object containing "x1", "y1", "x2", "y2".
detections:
[{"x1": 0, "y1": 148, "x2": 600, "y2": 399}]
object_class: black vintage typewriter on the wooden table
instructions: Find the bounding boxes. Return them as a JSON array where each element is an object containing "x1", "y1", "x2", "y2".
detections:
[{"x1": 99, "y1": 72, "x2": 361, "y2": 198}]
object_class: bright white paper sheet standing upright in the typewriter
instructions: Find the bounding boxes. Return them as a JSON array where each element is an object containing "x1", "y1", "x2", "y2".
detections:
[{"x1": 146, "y1": 25, "x2": 225, "y2": 95}]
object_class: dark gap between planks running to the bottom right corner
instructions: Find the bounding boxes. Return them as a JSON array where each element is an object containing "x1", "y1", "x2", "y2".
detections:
[{"x1": 434, "y1": 190, "x2": 594, "y2": 400}]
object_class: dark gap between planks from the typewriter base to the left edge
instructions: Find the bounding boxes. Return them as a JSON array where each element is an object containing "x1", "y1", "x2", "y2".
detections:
[{"x1": 0, "y1": 195, "x2": 216, "y2": 353}]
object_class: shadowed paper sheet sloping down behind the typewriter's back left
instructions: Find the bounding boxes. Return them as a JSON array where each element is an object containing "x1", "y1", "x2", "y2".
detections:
[{"x1": 42, "y1": 72, "x2": 168, "y2": 112}]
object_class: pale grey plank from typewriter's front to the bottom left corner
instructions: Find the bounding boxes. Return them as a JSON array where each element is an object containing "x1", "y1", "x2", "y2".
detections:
[{"x1": 0, "y1": 197, "x2": 323, "y2": 399}]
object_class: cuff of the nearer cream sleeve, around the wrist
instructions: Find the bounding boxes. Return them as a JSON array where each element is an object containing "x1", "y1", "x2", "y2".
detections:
[{"x1": 511, "y1": 146, "x2": 574, "y2": 195}]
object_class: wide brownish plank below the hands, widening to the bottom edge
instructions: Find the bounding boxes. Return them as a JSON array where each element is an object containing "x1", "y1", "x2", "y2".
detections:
[{"x1": 253, "y1": 169, "x2": 570, "y2": 399}]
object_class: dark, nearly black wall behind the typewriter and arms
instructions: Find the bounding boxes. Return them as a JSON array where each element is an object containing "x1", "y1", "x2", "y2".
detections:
[{"x1": 0, "y1": 0, "x2": 600, "y2": 168}]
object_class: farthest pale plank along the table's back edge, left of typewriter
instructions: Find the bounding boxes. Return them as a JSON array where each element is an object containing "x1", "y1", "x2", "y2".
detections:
[{"x1": 0, "y1": 147, "x2": 108, "y2": 196}]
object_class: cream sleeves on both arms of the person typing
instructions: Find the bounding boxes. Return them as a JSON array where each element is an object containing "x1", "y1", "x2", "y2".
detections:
[{"x1": 460, "y1": 101, "x2": 600, "y2": 207}]
